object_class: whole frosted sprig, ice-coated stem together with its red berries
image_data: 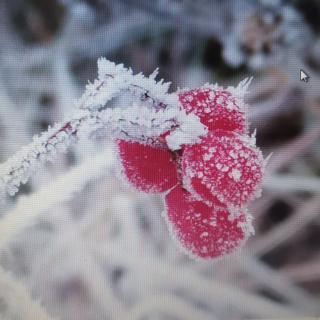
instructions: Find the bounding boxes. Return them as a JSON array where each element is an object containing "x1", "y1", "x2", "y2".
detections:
[{"x1": 0, "y1": 59, "x2": 264, "y2": 259}]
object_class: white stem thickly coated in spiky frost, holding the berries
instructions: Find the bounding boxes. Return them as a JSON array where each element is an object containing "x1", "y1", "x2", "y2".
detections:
[{"x1": 0, "y1": 59, "x2": 206, "y2": 198}]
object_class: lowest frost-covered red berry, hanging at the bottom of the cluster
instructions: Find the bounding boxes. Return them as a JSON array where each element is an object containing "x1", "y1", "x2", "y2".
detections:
[{"x1": 165, "y1": 186, "x2": 253, "y2": 259}]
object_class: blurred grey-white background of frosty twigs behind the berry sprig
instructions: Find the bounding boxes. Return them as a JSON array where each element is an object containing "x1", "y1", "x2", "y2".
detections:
[{"x1": 0, "y1": 0, "x2": 320, "y2": 320}]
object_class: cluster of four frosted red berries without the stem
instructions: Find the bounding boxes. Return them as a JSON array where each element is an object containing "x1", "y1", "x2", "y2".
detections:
[{"x1": 117, "y1": 86, "x2": 264, "y2": 259}]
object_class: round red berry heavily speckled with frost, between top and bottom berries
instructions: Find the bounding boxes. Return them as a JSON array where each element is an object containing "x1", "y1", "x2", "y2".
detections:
[{"x1": 181, "y1": 131, "x2": 264, "y2": 208}]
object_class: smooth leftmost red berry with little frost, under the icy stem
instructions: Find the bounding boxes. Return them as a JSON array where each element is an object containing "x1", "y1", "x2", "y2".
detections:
[{"x1": 117, "y1": 140, "x2": 178, "y2": 192}]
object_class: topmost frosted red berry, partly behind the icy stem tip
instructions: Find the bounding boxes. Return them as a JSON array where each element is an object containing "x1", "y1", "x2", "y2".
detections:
[{"x1": 178, "y1": 87, "x2": 246, "y2": 133}]
